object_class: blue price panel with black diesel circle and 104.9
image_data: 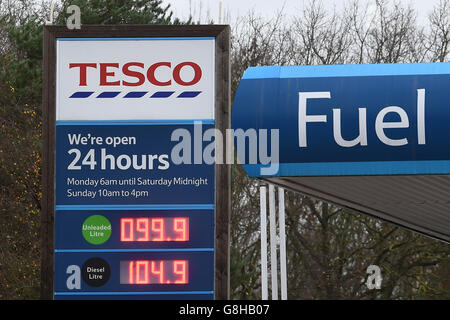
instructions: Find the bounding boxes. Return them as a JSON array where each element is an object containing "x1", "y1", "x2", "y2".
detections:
[{"x1": 55, "y1": 250, "x2": 214, "y2": 300}]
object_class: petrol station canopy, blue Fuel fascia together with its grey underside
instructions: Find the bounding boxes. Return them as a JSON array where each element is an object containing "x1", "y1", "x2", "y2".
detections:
[{"x1": 232, "y1": 63, "x2": 450, "y2": 242}]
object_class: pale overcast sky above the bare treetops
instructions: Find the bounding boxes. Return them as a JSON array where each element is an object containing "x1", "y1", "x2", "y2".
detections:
[{"x1": 164, "y1": 0, "x2": 439, "y2": 25}]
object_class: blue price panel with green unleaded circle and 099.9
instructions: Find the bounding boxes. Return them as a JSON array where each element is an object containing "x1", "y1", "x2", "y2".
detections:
[{"x1": 55, "y1": 209, "x2": 214, "y2": 250}]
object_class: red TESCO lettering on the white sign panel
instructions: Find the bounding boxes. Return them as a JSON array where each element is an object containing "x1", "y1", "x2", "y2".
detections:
[{"x1": 69, "y1": 61, "x2": 202, "y2": 87}]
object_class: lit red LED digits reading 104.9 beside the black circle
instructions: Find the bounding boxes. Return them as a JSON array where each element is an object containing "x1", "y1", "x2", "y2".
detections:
[{"x1": 120, "y1": 260, "x2": 189, "y2": 285}]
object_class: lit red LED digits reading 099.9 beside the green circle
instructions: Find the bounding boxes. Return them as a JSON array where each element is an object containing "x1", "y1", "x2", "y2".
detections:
[{"x1": 120, "y1": 217, "x2": 189, "y2": 242}]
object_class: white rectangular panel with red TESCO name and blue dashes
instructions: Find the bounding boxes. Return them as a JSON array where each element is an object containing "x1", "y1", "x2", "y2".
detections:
[{"x1": 56, "y1": 38, "x2": 215, "y2": 121}]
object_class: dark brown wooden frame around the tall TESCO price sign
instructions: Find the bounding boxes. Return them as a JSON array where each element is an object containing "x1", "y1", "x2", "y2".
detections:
[{"x1": 41, "y1": 25, "x2": 231, "y2": 300}]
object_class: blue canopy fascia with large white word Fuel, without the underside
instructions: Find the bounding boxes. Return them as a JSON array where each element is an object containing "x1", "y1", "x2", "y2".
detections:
[{"x1": 233, "y1": 63, "x2": 450, "y2": 177}]
